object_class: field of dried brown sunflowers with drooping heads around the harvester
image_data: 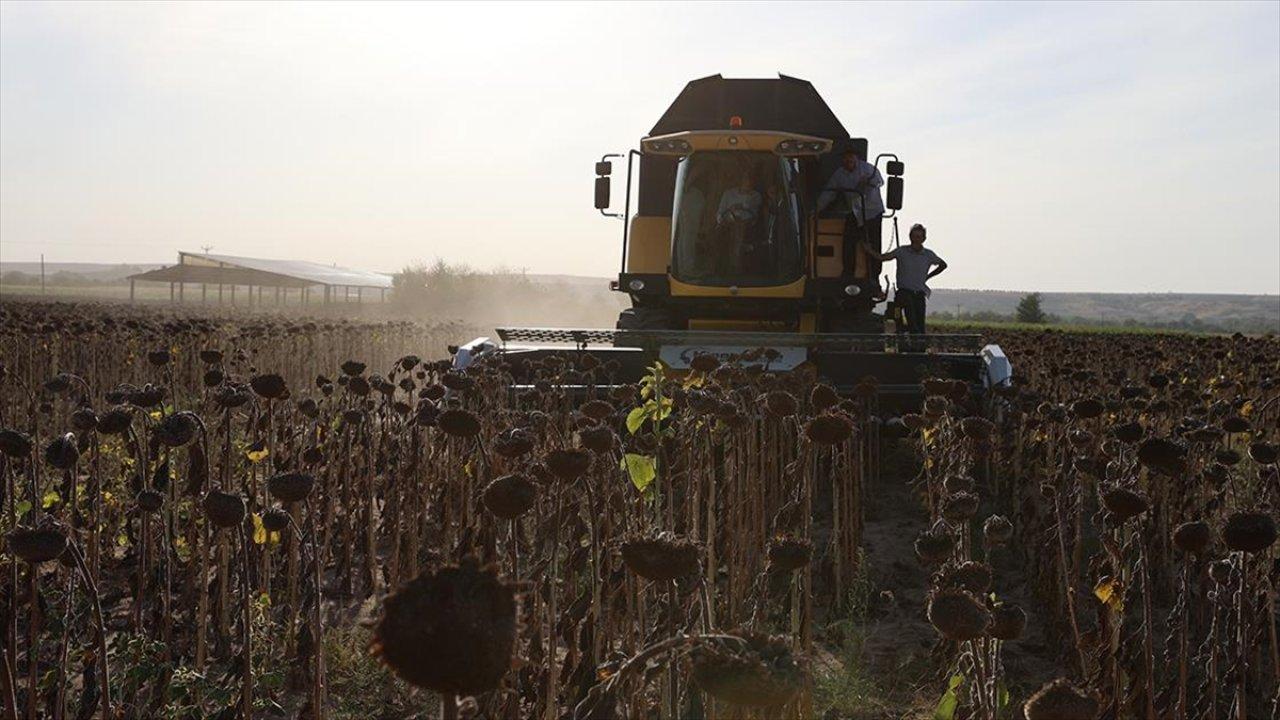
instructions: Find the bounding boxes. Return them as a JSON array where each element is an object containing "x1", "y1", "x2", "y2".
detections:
[{"x1": 0, "y1": 295, "x2": 1280, "y2": 720}]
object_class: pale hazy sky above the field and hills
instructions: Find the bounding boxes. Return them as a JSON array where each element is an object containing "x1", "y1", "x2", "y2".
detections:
[{"x1": 0, "y1": 1, "x2": 1280, "y2": 293}]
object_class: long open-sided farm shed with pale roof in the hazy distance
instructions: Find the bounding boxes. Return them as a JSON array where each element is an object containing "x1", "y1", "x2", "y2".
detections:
[{"x1": 129, "y1": 251, "x2": 392, "y2": 305}]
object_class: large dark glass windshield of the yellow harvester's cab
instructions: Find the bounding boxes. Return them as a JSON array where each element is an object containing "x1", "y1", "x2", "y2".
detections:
[{"x1": 671, "y1": 151, "x2": 803, "y2": 286}]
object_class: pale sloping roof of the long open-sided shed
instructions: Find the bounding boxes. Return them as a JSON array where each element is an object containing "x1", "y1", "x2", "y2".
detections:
[{"x1": 129, "y1": 251, "x2": 392, "y2": 288}]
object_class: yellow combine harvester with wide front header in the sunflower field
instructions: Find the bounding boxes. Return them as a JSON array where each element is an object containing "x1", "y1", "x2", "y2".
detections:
[{"x1": 454, "y1": 76, "x2": 1010, "y2": 395}]
